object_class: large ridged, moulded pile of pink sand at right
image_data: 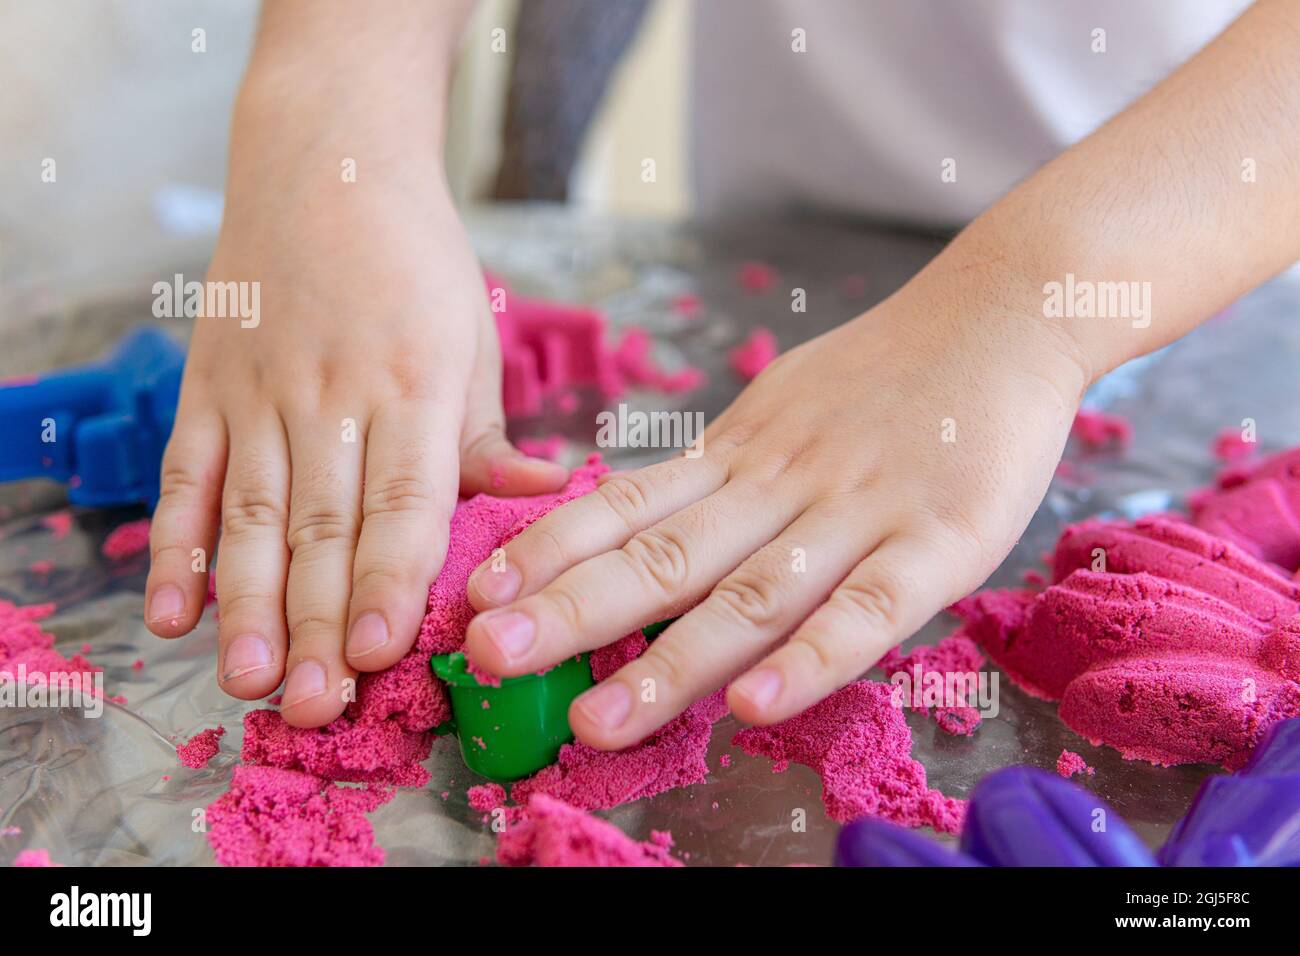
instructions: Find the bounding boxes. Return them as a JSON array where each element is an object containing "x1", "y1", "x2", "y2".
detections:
[{"x1": 956, "y1": 449, "x2": 1300, "y2": 770}]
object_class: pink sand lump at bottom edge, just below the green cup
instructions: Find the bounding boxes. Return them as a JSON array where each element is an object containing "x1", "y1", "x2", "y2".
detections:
[{"x1": 497, "y1": 793, "x2": 681, "y2": 866}]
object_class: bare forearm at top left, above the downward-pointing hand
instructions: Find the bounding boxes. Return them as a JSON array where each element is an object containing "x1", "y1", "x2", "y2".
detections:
[{"x1": 228, "y1": 0, "x2": 473, "y2": 212}]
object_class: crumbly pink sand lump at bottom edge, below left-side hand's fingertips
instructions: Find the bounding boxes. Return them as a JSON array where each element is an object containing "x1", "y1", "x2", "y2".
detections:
[{"x1": 208, "y1": 766, "x2": 393, "y2": 866}]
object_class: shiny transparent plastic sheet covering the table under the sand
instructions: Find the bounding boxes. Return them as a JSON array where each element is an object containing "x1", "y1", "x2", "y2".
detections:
[{"x1": 0, "y1": 208, "x2": 1300, "y2": 865}]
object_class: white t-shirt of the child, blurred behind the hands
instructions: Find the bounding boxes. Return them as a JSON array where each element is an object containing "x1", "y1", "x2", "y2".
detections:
[{"x1": 692, "y1": 0, "x2": 1249, "y2": 225}]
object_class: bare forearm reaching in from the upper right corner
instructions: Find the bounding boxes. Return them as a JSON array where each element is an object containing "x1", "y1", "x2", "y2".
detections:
[{"x1": 918, "y1": 0, "x2": 1300, "y2": 378}]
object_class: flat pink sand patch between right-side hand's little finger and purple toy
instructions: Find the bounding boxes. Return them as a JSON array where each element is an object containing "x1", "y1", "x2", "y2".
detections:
[{"x1": 732, "y1": 680, "x2": 966, "y2": 832}]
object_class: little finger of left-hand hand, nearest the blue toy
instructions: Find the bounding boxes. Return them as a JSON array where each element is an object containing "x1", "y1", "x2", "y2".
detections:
[{"x1": 144, "y1": 410, "x2": 226, "y2": 637}]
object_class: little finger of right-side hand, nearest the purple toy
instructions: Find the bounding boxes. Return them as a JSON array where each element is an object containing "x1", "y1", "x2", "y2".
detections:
[{"x1": 727, "y1": 533, "x2": 959, "y2": 723}]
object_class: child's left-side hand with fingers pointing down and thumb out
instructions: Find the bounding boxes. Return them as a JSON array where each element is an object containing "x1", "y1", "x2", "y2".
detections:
[{"x1": 146, "y1": 184, "x2": 567, "y2": 727}]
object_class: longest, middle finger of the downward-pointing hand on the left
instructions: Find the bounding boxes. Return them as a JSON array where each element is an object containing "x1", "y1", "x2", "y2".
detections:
[{"x1": 280, "y1": 411, "x2": 368, "y2": 727}]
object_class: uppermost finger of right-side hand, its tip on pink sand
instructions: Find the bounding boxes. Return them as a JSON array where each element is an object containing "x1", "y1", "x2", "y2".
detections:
[{"x1": 468, "y1": 454, "x2": 727, "y2": 611}]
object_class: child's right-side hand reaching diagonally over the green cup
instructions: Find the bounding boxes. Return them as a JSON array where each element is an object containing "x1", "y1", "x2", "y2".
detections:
[{"x1": 467, "y1": 280, "x2": 1089, "y2": 749}]
